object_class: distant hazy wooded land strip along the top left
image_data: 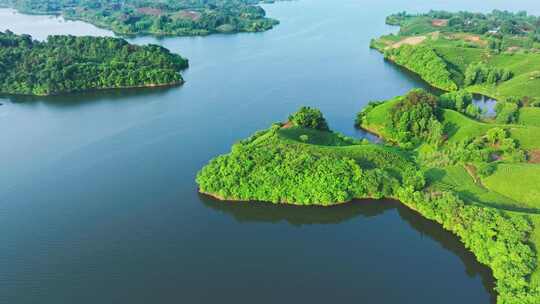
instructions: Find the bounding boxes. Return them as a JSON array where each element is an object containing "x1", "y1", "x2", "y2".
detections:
[{"x1": 0, "y1": 0, "x2": 279, "y2": 36}]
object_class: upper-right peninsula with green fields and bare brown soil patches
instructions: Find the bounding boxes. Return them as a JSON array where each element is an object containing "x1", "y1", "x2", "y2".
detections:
[{"x1": 371, "y1": 10, "x2": 540, "y2": 106}]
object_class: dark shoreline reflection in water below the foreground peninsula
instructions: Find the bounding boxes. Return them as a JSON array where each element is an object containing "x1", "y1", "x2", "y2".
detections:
[{"x1": 204, "y1": 194, "x2": 496, "y2": 303}]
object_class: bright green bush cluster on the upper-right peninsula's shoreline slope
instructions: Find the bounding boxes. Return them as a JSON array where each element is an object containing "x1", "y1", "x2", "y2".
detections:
[{"x1": 385, "y1": 45, "x2": 458, "y2": 91}]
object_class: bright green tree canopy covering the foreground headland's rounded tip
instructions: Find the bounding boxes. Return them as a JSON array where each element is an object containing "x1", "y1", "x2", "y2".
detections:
[{"x1": 197, "y1": 125, "x2": 408, "y2": 205}]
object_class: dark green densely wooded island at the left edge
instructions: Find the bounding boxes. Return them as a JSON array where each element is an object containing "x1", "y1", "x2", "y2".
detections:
[{"x1": 0, "y1": 31, "x2": 188, "y2": 96}]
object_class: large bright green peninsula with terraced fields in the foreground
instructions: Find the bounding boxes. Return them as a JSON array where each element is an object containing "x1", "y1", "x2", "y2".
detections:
[{"x1": 196, "y1": 97, "x2": 540, "y2": 304}]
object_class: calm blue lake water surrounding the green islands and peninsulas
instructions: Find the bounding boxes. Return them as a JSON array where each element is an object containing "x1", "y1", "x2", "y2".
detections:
[{"x1": 0, "y1": 0, "x2": 540, "y2": 304}]
